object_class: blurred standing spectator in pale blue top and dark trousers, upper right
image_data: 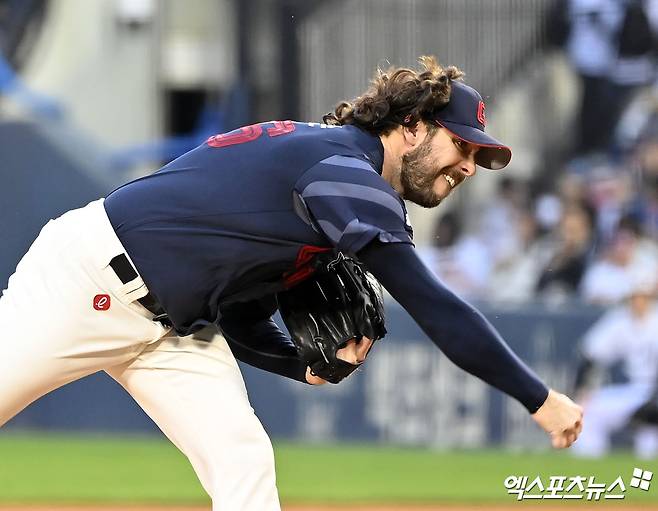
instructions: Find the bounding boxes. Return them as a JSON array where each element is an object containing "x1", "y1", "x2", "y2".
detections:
[{"x1": 548, "y1": 0, "x2": 658, "y2": 155}]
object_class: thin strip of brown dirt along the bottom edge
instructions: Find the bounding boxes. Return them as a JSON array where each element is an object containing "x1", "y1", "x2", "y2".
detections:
[{"x1": 0, "y1": 502, "x2": 658, "y2": 511}]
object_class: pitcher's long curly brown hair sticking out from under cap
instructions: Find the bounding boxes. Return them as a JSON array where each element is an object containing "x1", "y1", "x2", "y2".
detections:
[{"x1": 322, "y1": 55, "x2": 464, "y2": 135}]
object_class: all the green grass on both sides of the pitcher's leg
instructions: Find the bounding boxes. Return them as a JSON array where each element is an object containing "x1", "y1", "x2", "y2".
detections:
[{"x1": 0, "y1": 433, "x2": 658, "y2": 505}]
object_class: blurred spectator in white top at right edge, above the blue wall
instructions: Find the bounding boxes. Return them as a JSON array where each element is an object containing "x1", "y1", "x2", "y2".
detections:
[{"x1": 580, "y1": 217, "x2": 658, "y2": 305}]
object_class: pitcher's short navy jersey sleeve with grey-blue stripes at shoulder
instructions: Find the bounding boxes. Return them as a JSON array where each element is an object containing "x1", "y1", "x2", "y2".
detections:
[{"x1": 294, "y1": 155, "x2": 413, "y2": 253}]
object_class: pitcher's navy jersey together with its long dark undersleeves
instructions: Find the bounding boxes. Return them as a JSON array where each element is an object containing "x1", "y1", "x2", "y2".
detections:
[{"x1": 105, "y1": 121, "x2": 548, "y2": 412}]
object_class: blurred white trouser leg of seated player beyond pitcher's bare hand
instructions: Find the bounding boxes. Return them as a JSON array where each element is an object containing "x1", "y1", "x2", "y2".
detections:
[{"x1": 571, "y1": 383, "x2": 651, "y2": 457}]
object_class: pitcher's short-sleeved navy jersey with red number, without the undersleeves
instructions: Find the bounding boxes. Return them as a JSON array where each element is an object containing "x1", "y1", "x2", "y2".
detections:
[{"x1": 105, "y1": 121, "x2": 411, "y2": 335}]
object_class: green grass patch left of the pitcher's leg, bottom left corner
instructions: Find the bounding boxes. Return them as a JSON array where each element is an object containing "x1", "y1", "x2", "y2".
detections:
[{"x1": 0, "y1": 434, "x2": 208, "y2": 503}]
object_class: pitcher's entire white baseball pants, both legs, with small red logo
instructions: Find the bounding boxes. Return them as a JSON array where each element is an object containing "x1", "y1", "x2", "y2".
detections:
[{"x1": 0, "y1": 200, "x2": 280, "y2": 511}]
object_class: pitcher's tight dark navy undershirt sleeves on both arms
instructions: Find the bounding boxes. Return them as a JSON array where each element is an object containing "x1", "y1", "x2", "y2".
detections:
[{"x1": 221, "y1": 241, "x2": 548, "y2": 413}]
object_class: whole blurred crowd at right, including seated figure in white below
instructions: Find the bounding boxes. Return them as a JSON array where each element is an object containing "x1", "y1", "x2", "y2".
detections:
[{"x1": 421, "y1": 0, "x2": 658, "y2": 458}]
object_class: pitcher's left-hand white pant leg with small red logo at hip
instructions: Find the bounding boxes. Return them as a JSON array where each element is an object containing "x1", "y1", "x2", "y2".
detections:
[{"x1": 0, "y1": 201, "x2": 167, "y2": 426}]
